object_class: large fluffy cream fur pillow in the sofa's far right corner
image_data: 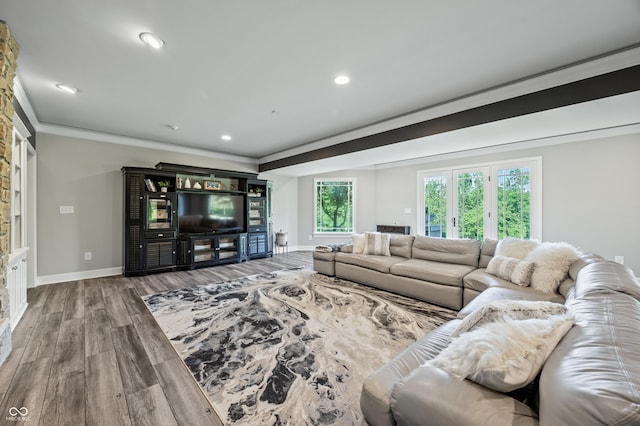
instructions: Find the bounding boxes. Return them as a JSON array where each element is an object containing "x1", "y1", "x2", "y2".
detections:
[{"x1": 526, "y1": 243, "x2": 580, "y2": 293}]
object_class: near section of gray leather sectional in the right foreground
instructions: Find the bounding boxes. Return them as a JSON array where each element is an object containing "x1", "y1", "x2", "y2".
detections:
[{"x1": 360, "y1": 261, "x2": 640, "y2": 426}]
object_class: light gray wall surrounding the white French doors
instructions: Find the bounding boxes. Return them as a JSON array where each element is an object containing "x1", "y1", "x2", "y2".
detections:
[{"x1": 330, "y1": 134, "x2": 640, "y2": 275}]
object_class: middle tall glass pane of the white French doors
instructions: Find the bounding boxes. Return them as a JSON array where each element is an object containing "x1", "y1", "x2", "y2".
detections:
[{"x1": 456, "y1": 172, "x2": 484, "y2": 241}]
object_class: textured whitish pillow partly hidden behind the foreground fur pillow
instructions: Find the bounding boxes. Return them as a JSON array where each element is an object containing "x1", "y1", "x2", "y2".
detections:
[{"x1": 451, "y1": 300, "x2": 567, "y2": 337}]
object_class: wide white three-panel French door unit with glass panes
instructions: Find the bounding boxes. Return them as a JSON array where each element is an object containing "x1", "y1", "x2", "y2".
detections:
[{"x1": 418, "y1": 158, "x2": 542, "y2": 240}]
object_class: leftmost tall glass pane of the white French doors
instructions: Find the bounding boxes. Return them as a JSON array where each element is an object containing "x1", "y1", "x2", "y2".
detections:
[{"x1": 424, "y1": 176, "x2": 447, "y2": 238}]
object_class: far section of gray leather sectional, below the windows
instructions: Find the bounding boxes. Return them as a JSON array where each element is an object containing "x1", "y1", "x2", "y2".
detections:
[{"x1": 313, "y1": 234, "x2": 572, "y2": 310}]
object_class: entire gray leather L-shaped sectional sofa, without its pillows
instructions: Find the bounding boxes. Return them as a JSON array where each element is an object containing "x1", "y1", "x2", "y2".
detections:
[{"x1": 314, "y1": 236, "x2": 640, "y2": 426}]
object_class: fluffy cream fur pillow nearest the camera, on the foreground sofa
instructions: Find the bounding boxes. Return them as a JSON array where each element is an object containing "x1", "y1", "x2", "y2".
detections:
[{"x1": 425, "y1": 314, "x2": 575, "y2": 392}]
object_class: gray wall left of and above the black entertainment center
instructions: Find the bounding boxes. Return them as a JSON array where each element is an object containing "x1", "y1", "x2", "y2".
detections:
[{"x1": 37, "y1": 133, "x2": 257, "y2": 277}]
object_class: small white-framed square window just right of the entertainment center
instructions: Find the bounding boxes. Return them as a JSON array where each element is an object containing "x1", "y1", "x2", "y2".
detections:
[{"x1": 314, "y1": 178, "x2": 356, "y2": 234}]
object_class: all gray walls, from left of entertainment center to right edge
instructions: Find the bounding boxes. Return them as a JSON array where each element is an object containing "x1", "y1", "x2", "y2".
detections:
[{"x1": 37, "y1": 130, "x2": 640, "y2": 277}]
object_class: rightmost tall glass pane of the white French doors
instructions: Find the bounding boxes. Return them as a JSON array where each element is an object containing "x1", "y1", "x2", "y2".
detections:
[{"x1": 497, "y1": 168, "x2": 531, "y2": 239}]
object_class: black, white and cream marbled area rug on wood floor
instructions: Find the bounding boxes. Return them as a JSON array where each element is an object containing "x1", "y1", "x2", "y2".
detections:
[{"x1": 144, "y1": 269, "x2": 455, "y2": 425}]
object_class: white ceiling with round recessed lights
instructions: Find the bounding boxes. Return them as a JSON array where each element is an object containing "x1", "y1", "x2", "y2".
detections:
[{"x1": 0, "y1": 0, "x2": 640, "y2": 173}]
